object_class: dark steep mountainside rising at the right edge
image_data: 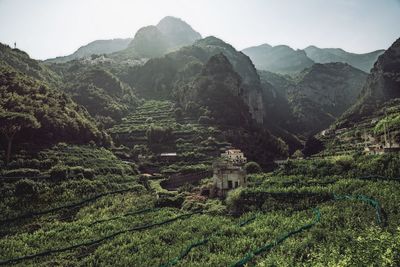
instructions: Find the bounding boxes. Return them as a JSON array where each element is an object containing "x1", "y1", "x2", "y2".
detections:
[{"x1": 339, "y1": 38, "x2": 400, "y2": 126}]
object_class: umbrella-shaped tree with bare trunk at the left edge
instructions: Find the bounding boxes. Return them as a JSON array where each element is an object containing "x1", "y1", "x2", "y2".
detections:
[{"x1": 0, "y1": 111, "x2": 40, "y2": 165}]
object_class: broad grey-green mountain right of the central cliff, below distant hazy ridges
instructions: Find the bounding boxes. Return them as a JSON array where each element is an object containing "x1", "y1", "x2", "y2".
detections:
[{"x1": 260, "y1": 63, "x2": 367, "y2": 138}]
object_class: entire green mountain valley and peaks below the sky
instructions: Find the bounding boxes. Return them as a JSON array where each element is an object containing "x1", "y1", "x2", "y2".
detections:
[{"x1": 0, "y1": 8, "x2": 400, "y2": 267}]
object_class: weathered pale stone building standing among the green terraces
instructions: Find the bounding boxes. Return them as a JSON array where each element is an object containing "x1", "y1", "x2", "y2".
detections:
[{"x1": 213, "y1": 149, "x2": 247, "y2": 197}]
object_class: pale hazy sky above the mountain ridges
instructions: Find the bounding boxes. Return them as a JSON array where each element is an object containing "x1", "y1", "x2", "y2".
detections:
[{"x1": 0, "y1": 0, "x2": 400, "y2": 59}]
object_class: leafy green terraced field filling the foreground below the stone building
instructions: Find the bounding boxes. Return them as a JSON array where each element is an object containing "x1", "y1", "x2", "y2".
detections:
[{"x1": 0, "y1": 147, "x2": 400, "y2": 266}]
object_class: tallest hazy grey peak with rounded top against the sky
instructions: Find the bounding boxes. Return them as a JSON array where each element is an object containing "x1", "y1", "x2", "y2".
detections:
[{"x1": 112, "y1": 17, "x2": 201, "y2": 61}]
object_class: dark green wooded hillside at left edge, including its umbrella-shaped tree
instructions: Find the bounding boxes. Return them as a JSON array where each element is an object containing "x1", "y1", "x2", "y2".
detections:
[{"x1": 0, "y1": 67, "x2": 110, "y2": 162}]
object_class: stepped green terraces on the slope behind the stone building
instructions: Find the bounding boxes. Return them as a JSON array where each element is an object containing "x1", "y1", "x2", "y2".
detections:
[{"x1": 109, "y1": 101, "x2": 231, "y2": 174}]
